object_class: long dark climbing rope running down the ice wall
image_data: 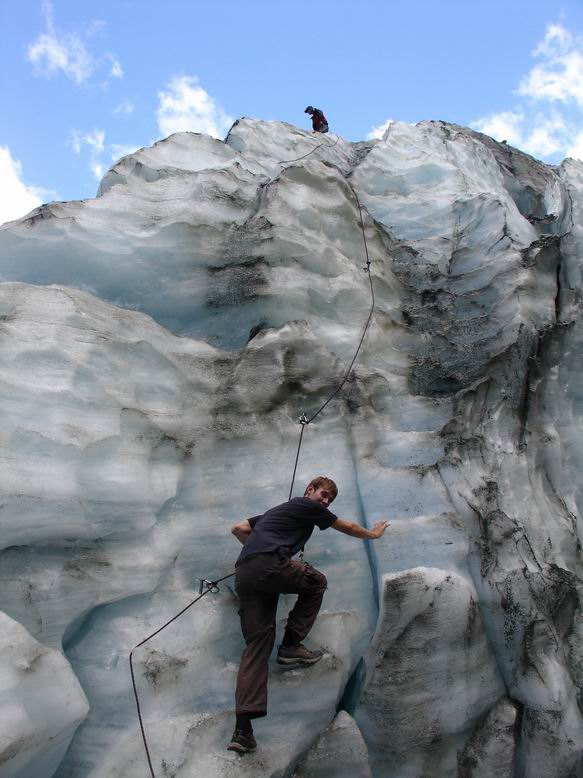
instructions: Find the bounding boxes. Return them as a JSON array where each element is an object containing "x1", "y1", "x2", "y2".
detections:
[{"x1": 129, "y1": 129, "x2": 375, "y2": 778}]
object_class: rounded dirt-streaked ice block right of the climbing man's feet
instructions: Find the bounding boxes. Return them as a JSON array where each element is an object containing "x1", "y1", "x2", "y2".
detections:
[{"x1": 357, "y1": 567, "x2": 504, "y2": 776}]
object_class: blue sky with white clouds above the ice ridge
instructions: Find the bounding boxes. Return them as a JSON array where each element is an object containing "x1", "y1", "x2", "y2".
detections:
[{"x1": 0, "y1": 0, "x2": 583, "y2": 223}]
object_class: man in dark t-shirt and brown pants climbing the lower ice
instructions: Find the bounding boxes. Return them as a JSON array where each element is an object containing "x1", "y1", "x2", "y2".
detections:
[{"x1": 227, "y1": 476, "x2": 389, "y2": 754}]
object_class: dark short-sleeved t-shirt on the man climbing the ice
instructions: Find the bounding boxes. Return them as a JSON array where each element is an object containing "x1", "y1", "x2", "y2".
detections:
[{"x1": 237, "y1": 497, "x2": 338, "y2": 564}]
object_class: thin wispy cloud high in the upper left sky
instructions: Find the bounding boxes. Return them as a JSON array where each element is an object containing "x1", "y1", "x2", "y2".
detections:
[{"x1": 26, "y1": 0, "x2": 123, "y2": 84}]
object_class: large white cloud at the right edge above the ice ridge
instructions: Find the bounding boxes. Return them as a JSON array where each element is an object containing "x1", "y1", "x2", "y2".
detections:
[{"x1": 471, "y1": 24, "x2": 583, "y2": 162}]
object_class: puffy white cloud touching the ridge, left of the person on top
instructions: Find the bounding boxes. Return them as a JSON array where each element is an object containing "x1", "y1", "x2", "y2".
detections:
[{"x1": 157, "y1": 76, "x2": 234, "y2": 138}]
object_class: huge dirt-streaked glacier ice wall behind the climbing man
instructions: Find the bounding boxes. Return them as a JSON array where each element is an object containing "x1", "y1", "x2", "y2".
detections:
[{"x1": 0, "y1": 119, "x2": 583, "y2": 778}]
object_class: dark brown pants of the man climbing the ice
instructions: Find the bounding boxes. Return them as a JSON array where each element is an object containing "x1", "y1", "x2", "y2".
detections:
[{"x1": 235, "y1": 552, "x2": 326, "y2": 718}]
